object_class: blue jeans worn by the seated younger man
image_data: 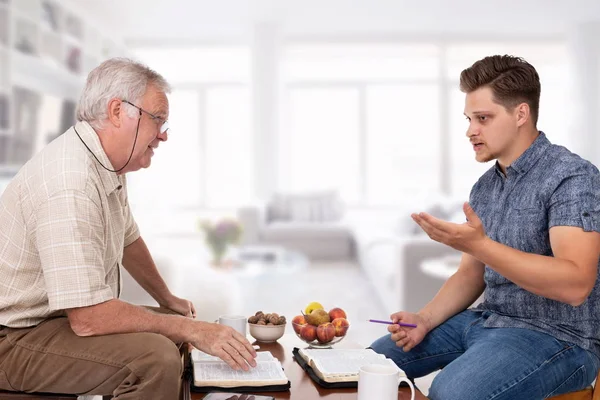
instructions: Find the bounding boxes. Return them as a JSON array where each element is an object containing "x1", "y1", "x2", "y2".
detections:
[{"x1": 371, "y1": 310, "x2": 600, "y2": 400}]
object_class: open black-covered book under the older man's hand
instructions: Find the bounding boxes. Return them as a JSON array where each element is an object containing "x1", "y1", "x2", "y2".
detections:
[{"x1": 192, "y1": 349, "x2": 289, "y2": 390}]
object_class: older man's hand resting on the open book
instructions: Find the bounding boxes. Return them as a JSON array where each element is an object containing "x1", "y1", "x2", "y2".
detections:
[{"x1": 191, "y1": 322, "x2": 256, "y2": 371}]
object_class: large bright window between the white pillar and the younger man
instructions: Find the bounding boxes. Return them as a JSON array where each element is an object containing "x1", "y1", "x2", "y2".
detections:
[{"x1": 280, "y1": 44, "x2": 440, "y2": 205}]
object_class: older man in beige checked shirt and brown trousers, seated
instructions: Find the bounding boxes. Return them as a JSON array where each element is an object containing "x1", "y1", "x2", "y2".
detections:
[{"x1": 0, "y1": 59, "x2": 256, "y2": 400}]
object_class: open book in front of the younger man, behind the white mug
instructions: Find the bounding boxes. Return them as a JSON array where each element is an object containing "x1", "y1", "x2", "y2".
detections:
[{"x1": 298, "y1": 349, "x2": 406, "y2": 383}]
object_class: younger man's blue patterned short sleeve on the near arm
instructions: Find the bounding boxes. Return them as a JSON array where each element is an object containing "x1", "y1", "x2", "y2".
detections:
[{"x1": 548, "y1": 172, "x2": 600, "y2": 232}]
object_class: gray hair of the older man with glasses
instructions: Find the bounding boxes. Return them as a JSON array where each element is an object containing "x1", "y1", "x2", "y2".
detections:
[{"x1": 77, "y1": 58, "x2": 171, "y2": 129}]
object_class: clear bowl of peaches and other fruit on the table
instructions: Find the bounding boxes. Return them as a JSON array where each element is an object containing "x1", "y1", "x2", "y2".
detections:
[{"x1": 292, "y1": 302, "x2": 350, "y2": 349}]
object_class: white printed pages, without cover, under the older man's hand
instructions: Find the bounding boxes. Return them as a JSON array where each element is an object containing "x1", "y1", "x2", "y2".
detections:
[{"x1": 194, "y1": 359, "x2": 288, "y2": 387}]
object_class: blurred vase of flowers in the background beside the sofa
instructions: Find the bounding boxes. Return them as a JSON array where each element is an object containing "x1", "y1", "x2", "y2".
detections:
[{"x1": 200, "y1": 218, "x2": 242, "y2": 265}]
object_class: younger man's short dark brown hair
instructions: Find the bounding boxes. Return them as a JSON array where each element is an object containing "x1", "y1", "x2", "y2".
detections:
[{"x1": 460, "y1": 55, "x2": 541, "y2": 126}]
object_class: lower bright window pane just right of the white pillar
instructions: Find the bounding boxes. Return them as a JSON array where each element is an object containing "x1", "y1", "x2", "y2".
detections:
[{"x1": 287, "y1": 87, "x2": 360, "y2": 202}]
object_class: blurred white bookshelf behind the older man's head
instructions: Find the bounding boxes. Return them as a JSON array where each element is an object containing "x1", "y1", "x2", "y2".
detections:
[{"x1": 0, "y1": 0, "x2": 127, "y2": 168}]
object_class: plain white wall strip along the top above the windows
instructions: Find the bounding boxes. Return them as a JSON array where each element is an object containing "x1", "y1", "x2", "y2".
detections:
[{"x1": 79, "y1": 0, "x2": 600, "y2": 41}]
